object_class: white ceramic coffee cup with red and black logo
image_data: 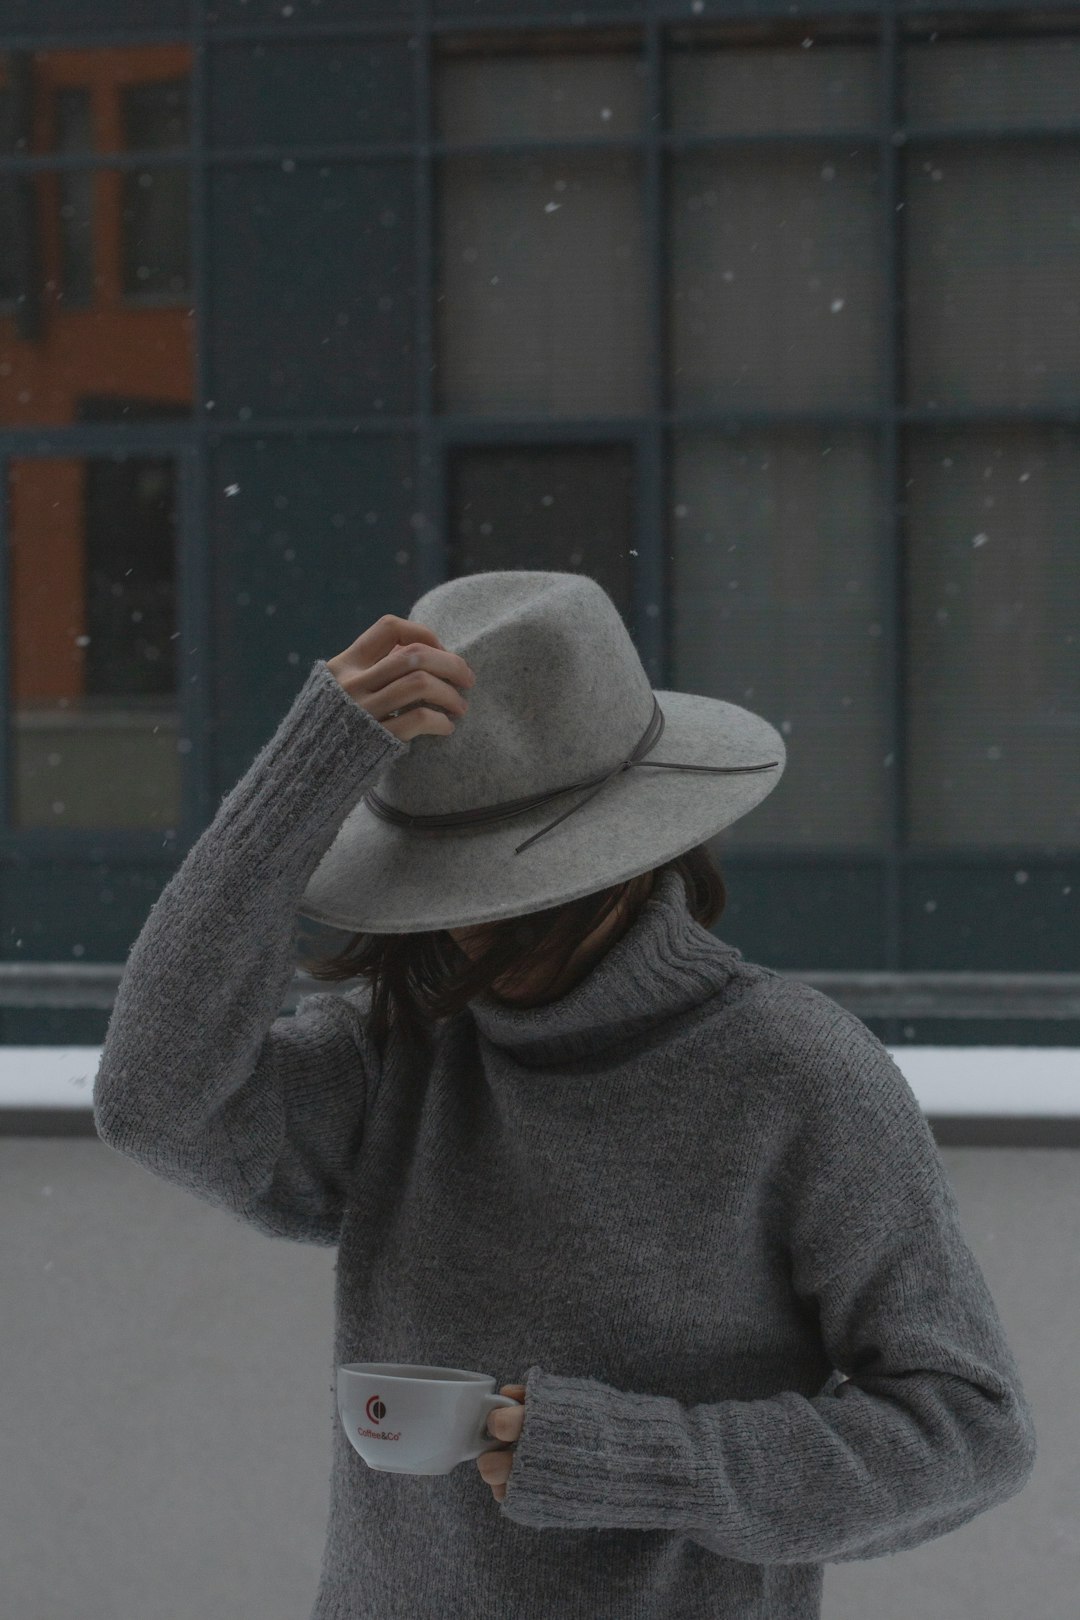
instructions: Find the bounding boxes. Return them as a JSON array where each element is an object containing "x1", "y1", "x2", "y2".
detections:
[{"x1": 337, "y1": 1361, "x2": 521, "y2": 1474}]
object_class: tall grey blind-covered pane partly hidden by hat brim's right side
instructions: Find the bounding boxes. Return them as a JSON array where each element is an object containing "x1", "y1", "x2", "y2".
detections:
[{"x1": 669, "y1": 428, "x2": 894, "y2": 851}]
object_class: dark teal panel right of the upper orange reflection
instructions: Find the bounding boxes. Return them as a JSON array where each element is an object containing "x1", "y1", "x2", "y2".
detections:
[{"x1": 210, "y1": 160, "x2": 416, "y2": 416}]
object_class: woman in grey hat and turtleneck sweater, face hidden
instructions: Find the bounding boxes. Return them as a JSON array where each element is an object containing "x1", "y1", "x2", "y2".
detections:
[{"x1": 94, "y1": 570, "x2": 1035, "y2": 1620}]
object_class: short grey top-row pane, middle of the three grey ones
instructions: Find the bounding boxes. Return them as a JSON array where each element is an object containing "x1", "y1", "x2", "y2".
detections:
[{"x1": 667, "y1": 41, "x2": 881, "y2": 134}]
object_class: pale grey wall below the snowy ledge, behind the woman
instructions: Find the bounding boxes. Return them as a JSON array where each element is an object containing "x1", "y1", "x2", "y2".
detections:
[{"x1": 0, "y1": 1137, "x2": 1080, "y2": 1620}]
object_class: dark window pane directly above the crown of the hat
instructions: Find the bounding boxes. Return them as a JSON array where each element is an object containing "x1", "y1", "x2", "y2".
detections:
[{"x1": 447, "y1": 444, "x2": 635, "y2": 624}]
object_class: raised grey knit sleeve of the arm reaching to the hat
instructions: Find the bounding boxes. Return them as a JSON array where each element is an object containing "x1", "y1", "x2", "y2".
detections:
[{"x1": 94, "y1": 659, "x2": 408, "y2": 1244}]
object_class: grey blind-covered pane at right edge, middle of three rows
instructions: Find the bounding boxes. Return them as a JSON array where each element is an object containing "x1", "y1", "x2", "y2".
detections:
[{"x1": 905, "y1": 141, "x2": 1080, "y2": 408}]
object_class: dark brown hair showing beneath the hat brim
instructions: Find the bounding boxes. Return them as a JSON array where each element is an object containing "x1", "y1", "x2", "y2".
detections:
[{"x1": 300, "y1": 844, "x2": 727, "y2": 1053}]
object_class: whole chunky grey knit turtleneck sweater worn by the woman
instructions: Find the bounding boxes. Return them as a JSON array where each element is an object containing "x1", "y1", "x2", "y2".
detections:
[{"x1": 94, "y1": 659, "x2": 1035, "y2": 1620}]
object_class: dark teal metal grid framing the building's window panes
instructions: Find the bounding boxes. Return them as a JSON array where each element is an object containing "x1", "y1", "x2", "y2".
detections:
[{"x1": 0, "y1": 0, "x2": 1080, "y2": 1016}]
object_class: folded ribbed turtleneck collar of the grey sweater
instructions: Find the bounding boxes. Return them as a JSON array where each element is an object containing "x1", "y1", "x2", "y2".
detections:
[{"x1": 470, "y1": 868, "x2": 740, "y2": 1068}]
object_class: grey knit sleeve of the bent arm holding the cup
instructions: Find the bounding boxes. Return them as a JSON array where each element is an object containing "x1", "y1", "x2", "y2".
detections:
[{"x1": 504, "y1": 998, "x2": 1036, "y2": 1563}]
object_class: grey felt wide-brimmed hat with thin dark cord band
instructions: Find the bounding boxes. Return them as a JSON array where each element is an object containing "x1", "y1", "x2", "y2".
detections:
[{"x1": 298, "y1": 569, "x2": 787, "y2": 933}]
